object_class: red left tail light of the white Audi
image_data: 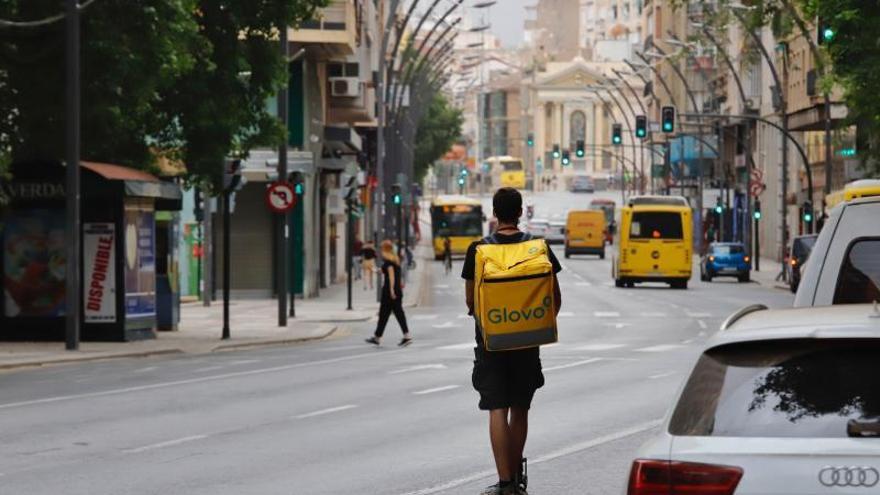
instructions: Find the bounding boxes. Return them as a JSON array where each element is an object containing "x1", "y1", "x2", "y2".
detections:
[{"x1": 627, "y1": 459, "x2": 743, "y2": 495}]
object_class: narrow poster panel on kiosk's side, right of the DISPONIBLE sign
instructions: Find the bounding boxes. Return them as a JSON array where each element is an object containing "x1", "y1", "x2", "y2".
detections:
[{"x1": 125, "y1": 203, "x2": 156, "y2": 318}]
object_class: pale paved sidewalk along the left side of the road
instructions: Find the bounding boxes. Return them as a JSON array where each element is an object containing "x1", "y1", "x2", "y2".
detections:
[{"x1": 0, "y1": 245, "x2": 430, "y2": 370}]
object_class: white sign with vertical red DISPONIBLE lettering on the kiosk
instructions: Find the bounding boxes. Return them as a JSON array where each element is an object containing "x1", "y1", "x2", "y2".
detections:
[{"x1": 83, "y1": 223, "x2": 116, "y2": 323}]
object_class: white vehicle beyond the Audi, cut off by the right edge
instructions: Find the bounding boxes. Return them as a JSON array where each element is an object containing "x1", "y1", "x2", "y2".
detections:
[{"x1": 794, "y1": 196, "x2": 880, "y2": 307}]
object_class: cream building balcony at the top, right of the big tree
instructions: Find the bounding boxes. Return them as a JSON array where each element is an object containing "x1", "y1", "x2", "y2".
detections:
[{"x1": 288, "y1": 0, "x2": 358, "y2": 55}]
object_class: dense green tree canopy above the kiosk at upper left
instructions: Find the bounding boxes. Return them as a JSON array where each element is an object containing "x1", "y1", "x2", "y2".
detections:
[{"x1": 0, "y1": 0, "x2": 329, "y2": 190}]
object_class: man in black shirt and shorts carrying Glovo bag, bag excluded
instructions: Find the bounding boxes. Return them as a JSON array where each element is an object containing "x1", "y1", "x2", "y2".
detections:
[{"x1": 461, "y1": 187, "x2": 562, "y2": 495}]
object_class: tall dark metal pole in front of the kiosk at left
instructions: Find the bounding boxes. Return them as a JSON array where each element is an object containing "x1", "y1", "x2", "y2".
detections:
[{"x1": 64, "y1": 0, "x2": 82, "y2": 351}]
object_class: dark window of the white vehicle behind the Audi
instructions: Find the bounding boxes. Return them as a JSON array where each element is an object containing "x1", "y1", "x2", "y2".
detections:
[{"x1": 832, "y1": 239, "x2": 880, "y2": 304}]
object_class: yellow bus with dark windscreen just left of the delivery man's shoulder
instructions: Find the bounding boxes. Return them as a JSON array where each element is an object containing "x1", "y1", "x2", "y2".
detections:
[{"x1": 431, "y1": 195, "x2": 483, "y2": 260}]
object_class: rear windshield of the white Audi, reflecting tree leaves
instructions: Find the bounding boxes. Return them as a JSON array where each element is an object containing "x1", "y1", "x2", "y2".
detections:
[{"x1": 669, "y1": 339, "x2": 880, "y2": 441}]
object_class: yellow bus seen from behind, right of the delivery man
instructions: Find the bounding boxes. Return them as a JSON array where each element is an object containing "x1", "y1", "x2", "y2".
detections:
[{"x1": 612, "y1": 196, "x2": 693, "y2": 289}]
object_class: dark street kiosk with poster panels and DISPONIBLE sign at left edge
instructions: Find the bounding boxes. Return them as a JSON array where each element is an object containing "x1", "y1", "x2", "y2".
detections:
[{"x1": 0, "y1": 162, "x2": 181, "y2": 341}]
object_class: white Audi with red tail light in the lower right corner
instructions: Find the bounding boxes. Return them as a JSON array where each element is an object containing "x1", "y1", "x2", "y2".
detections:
[{"x1": 625, "y1": 304, "x2": 880, "y2": 495}]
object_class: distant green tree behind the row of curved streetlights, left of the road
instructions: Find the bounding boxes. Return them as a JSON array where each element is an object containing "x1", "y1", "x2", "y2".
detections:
[{"x1": 414, "y1": 93, "x2": 464, "y2": 182}]
